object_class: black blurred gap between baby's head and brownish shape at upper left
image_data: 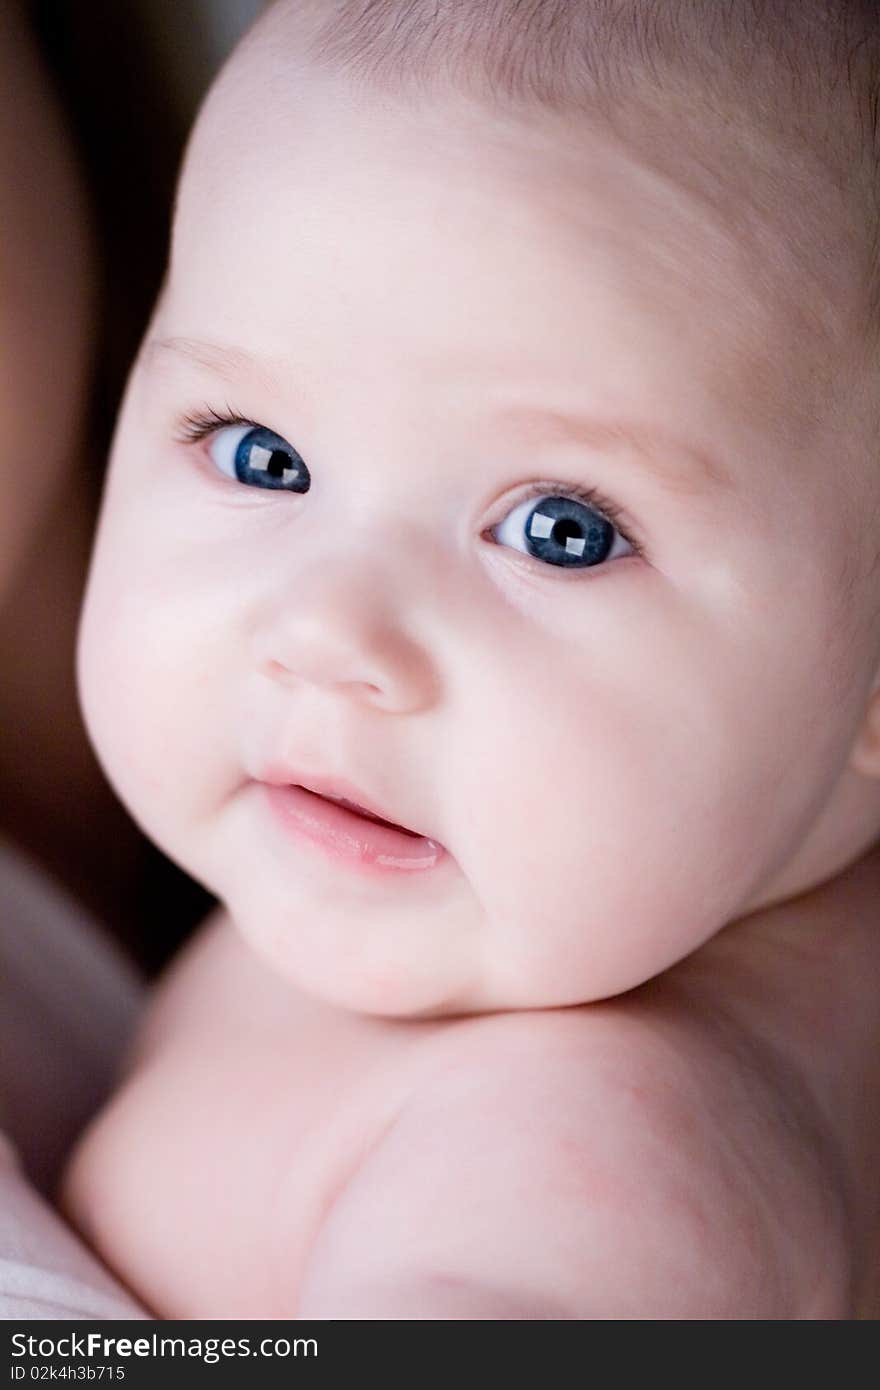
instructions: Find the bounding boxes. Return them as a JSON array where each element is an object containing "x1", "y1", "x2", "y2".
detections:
[{"x1": 27, "y1": 0, "x2": 264, "y2": 425}]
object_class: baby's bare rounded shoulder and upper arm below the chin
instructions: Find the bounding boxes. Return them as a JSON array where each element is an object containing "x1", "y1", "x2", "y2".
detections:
[{"x1": 296, "y1": 1011, "x2": 847, "y2": 1319}]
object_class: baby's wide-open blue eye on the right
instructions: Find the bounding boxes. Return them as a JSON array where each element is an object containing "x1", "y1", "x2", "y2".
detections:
[{"x1": 491, "y1": 492, "x2": 638, "y2": 570}]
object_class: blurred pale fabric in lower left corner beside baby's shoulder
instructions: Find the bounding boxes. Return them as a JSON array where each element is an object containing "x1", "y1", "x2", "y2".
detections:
[{"x1": 0, "y1": 844, "x2": 150, "y2": 1321}]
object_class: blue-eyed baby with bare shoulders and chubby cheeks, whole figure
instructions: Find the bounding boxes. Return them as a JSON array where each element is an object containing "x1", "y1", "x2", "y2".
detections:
[{"x1": 60, "y1": 0, "x2": 880, "y2": 1319}]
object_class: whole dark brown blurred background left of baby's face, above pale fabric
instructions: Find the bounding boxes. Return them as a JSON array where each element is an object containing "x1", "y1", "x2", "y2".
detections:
[{"x1": 0, "y1": 0, "x2": 264, "y2": 976}]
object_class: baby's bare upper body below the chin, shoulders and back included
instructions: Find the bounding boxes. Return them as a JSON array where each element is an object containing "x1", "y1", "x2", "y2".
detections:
[{"x1": 63, "y1": 834, "x2": 880, "y2": 1319}]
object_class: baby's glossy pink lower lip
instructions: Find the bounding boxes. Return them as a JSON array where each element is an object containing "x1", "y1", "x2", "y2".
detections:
[{"x1": 264, "y1": 784, "x2": 448, "y2": 874}]
